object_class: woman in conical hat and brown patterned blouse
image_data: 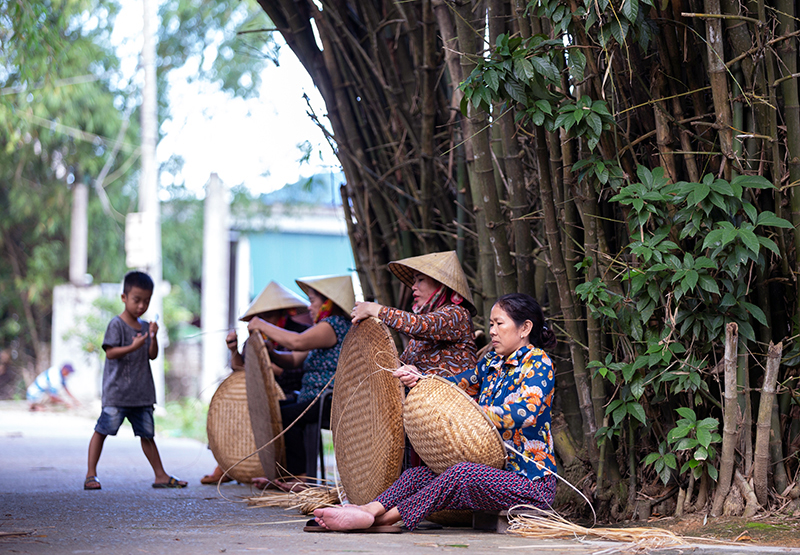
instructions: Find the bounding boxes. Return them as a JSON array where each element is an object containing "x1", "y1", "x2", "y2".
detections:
[{"x1": 351, "y1": 251, "x2": 476, "y2": 376}]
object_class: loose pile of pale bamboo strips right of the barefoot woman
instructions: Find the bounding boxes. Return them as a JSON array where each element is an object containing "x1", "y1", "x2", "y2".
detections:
[{"x1": 508, "y1": 514, "x2": 686, "y2": 551}]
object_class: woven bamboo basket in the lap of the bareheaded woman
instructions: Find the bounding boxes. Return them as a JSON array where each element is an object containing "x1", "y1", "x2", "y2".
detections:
[{"x1": 403, "y1": 376, "x2": 506, "y2": 474}]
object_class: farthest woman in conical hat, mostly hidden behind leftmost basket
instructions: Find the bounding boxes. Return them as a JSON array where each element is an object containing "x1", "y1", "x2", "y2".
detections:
[{"x1": 200, "y1": 281, "x2": 311, "y2": 485}]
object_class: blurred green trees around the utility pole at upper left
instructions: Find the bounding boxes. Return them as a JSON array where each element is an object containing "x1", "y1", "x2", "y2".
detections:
[{"x1": 0, "y1": 0, "x2": 273, "y2": 392}]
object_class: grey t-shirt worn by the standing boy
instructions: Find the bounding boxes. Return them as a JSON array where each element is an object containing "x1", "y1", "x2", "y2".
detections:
[{"x1": 103, "y1": 316, "x2": 156, "y2": 407}]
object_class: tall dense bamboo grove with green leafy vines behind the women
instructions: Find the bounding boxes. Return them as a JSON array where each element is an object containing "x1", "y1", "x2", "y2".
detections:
[{"x1": 259, "y1": 0, "x2": 800, "y2": 518}]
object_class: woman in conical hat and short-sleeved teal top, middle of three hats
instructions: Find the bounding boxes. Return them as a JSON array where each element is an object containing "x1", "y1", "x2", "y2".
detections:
[{"x1": 247, "y1": 276, "x2": 355, "y2": 485}]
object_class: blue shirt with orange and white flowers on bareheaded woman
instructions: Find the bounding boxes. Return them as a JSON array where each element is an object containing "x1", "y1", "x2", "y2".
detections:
[{"x1": 447, "y1": 345, "x2": 556, "y2": 480}]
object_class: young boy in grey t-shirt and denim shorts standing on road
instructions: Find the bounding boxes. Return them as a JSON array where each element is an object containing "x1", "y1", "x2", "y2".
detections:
[{"x1": 83, "y1": 271, "x2": 188, "y2": 490}]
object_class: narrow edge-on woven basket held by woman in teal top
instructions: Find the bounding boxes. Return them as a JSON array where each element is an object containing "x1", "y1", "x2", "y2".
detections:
[{"x1": 244, "y1": 331, "x2": 286, "y2": 480}]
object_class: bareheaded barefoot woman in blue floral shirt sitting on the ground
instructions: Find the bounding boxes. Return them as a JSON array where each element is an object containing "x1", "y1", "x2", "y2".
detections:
[{"x1": 314, "y1": 293, "x2": 556, "y2": 530}]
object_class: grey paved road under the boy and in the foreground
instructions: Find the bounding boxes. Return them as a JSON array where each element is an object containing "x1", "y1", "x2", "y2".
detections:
[{"x1": 0, "y1": 402, "x2": 800, "y2": 555}]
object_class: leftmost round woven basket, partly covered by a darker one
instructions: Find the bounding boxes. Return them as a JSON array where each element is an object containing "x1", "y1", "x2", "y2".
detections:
[{"x1": 206, "y1": 372, "x2": 264, "y2": 483}]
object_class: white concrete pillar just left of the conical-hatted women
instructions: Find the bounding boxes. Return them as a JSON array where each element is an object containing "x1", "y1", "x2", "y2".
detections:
[{"x1": 200, "y1": 173, "x2": 230, "y2": 401}]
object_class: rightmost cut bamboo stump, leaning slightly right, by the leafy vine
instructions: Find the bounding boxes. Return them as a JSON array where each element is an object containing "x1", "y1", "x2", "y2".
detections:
[{"x1": 753, "y1": 343, "x2": 783, "y2": 507}]
